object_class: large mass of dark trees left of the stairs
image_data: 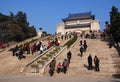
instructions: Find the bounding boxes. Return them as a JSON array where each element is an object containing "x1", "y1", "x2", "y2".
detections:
[{"x1": 0, "y1": 11, "x2": 37, "y2": 42}]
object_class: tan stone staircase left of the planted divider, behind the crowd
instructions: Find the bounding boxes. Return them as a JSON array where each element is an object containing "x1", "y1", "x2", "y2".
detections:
[{"x1": 0, "y1": 36, "x2": 71, "y2": 75}]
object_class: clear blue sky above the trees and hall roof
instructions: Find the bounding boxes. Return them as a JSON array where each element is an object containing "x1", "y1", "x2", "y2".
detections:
[{"x1": 0, "y1": 0, "x2": 120, "y2": 33}]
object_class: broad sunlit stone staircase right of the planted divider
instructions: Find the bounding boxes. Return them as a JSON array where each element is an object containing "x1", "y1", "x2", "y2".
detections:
[{"x1": 45, "y1": 38, "x2": 120, "y2": 78}]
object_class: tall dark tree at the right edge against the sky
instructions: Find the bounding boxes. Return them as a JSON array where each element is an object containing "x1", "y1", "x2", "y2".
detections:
[{"x1": 110, "y1": 6, "x2": 120, "y2": 42}]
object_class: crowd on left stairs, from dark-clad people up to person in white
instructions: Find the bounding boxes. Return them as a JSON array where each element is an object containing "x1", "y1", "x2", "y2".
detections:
[{"x1": 12, "y1": 41, "x2": 47, "y2": 60}]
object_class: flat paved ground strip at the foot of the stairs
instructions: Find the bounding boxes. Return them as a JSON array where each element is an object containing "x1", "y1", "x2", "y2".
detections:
[{"x1": 0, "y1": 76, "x2": 120, "y2": 82}]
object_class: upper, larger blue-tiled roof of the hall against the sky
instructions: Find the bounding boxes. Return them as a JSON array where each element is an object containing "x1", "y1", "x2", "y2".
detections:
[{"x1": 63, "y1": 12, "x2": 94, "y2": 21}]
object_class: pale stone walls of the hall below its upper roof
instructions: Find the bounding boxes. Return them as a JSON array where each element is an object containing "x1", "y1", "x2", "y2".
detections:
[{"x1": 57, "y1": 19, "x2": 100, "y2": 34}]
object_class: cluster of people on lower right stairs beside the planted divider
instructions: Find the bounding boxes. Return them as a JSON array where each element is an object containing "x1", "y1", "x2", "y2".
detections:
[{"x1": 49, "y1": 51, "x2": 72, "y2": 76}]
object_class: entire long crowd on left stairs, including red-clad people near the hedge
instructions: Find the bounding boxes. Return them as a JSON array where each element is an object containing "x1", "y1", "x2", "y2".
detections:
[{"x1": 12, "y1": 36, "x2": 63, "y2": 60}]
